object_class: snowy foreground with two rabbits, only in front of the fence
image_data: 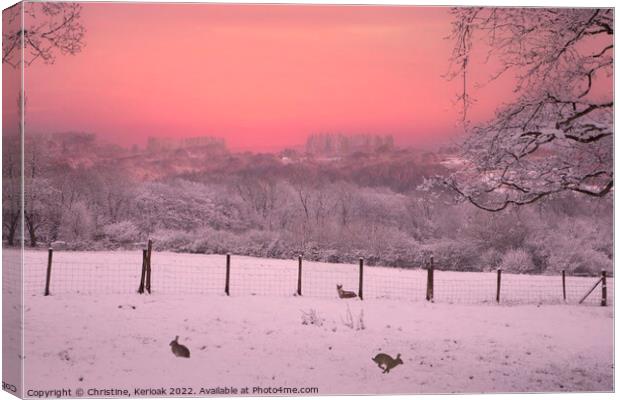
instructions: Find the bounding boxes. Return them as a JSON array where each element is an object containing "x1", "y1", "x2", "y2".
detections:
[{"x1": 25, "y1": 295, "x2": 613, "y2": 394}]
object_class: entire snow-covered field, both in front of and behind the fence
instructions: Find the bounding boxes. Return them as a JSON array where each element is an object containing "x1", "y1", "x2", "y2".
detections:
[{"x1": 4, "y1": 252, "x2": 613, "y2": 395}]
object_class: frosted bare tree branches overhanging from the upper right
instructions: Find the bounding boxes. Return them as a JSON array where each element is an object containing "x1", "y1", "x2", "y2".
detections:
[{"x1": 442, "y1": 8, "x2": 614, "y2": 211}]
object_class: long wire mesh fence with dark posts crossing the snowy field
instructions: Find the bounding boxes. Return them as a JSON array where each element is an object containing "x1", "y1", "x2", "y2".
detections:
[{"x1": 17, "y1": 251, "x2": 614, "y2": 305}]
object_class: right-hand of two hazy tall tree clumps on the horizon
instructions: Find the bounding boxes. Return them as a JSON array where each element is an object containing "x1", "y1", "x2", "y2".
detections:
[{"x1": 306, "y1": 134, "x2": 394, "y2": 156}]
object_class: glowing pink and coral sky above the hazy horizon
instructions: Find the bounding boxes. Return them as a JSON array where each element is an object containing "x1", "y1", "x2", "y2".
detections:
[{"x1": 21, "y1": 3, "x2": 504, "y2": 150}]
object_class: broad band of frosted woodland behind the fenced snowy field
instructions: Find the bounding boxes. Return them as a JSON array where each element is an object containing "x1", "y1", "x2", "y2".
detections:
[{"x1": 3, "y1": 134, "x2": 612, "y2": 273}]
